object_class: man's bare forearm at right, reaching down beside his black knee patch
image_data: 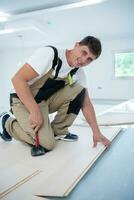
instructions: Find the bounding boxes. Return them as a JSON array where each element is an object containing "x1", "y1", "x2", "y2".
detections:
[{"x1": 82, "y1": 93, "x2": 100, "y2": 134}]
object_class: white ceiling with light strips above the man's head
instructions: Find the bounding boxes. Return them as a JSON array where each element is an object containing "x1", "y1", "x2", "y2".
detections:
[{"x1": 0, "y1": 0, "x2": 134, "y2": 48}]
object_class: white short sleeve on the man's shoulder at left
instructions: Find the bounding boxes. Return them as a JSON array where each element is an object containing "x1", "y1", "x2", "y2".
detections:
[{"x1": 26, "y1": 47, "x2": 54, "y2": 76}]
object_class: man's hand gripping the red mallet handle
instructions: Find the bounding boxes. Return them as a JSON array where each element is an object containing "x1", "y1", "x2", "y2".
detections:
[{"x1": 29, "y1": 110, "x2": 44, "y2": 132}]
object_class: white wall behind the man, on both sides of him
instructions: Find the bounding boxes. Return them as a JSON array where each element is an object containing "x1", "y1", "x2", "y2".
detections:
[{"x1": 0, "y1": 38, "x2": 134, "y2": 109}]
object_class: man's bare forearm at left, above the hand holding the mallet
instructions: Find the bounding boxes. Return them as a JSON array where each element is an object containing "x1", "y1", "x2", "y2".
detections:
[{"x1": 12, "y1": 77, "x2": 39, "y2": 113}]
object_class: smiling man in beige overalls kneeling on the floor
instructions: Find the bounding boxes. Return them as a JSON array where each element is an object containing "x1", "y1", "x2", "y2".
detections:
[{"x1": 1, "y1": 36, "x2": 110, "y2": 155}]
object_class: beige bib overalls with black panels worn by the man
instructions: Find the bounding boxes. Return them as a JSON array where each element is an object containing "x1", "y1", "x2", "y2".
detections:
[{"x1": 6, "y1": 47, "x2": 85, "y2": 150}]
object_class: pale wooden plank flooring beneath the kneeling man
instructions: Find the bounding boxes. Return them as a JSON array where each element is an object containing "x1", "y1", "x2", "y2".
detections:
[{"x1": 0, "y1": 127, "x2": 119, "y2": 199}]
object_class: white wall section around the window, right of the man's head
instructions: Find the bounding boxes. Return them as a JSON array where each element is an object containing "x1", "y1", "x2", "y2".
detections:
[{"x1": 86, "y1": 37, "x2": 134, "y2": 100}]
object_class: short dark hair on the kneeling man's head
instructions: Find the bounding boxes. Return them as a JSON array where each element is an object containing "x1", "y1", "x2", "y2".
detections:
[{"x1": 79, "y1": 36, "x2": 102, "y2": 58}]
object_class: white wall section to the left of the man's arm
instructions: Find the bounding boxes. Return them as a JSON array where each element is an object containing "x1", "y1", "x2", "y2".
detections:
[{"x1": 0, "y1": 48, "x2": 34, "y2": 110}]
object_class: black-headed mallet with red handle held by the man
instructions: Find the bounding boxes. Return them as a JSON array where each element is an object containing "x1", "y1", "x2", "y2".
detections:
[{"x1": 31, "y1": 131, "x2": 45, "y2": 156}]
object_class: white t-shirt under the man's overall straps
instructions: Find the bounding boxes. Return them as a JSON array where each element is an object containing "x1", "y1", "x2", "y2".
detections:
[{"x1": 12, "y1": 47, "x2": 87, "y2": 92}]
